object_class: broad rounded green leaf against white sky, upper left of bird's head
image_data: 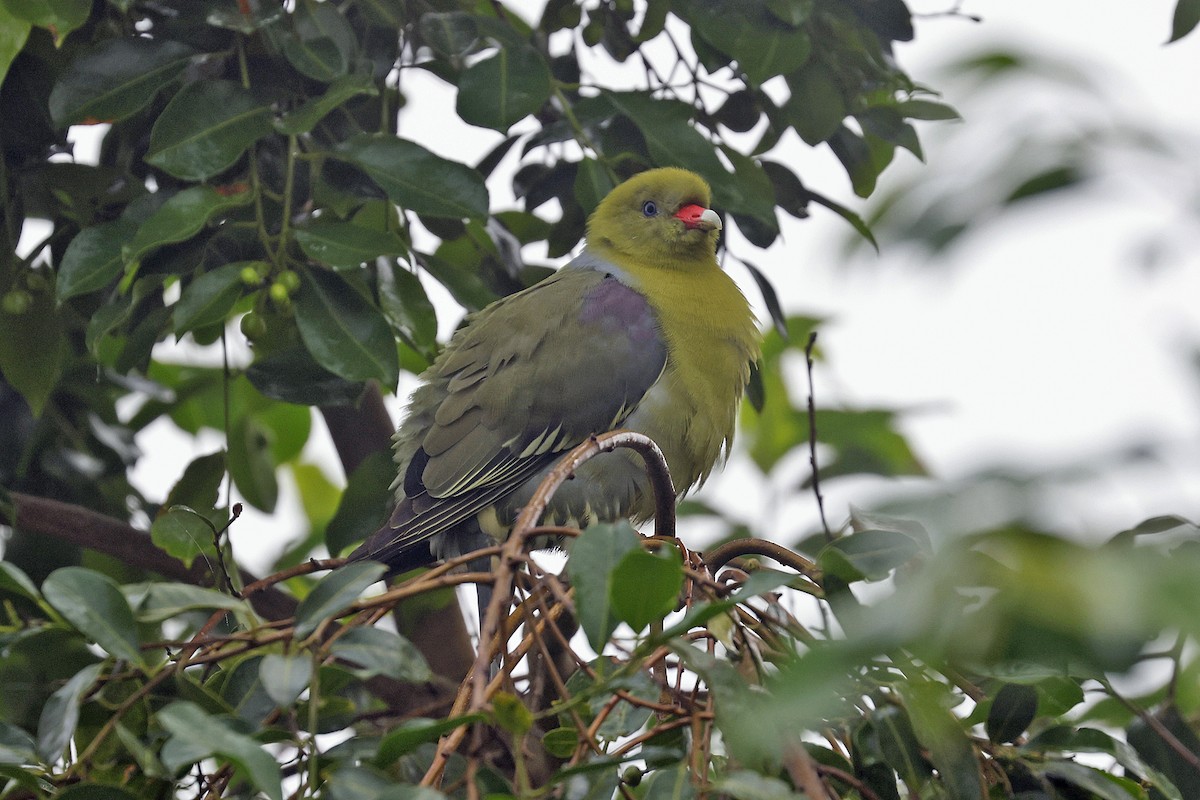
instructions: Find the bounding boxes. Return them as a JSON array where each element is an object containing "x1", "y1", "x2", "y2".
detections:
[{"x1": 456, "y1": 43, "x2": 551, "y2": 133}]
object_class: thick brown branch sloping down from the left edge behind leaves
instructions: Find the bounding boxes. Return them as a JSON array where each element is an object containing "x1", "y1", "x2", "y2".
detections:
[{"x1": 11, "y1": 492, "x2": 296, "y2": 620}]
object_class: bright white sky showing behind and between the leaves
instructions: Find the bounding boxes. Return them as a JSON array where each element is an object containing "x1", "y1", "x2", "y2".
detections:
[{"x1": 103, "y1": 0, "x2": 1200, "y2": 569}]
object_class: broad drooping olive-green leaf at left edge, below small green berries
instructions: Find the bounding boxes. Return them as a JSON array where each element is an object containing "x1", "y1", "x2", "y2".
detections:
[{"x1": 0, "y1": 278, "x2": 70, "y2": 417}]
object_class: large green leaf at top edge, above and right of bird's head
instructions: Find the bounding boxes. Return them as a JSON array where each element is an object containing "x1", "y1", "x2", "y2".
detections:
[{"x1": 672, "y1": 0, "x2": 812, "y2": 84}]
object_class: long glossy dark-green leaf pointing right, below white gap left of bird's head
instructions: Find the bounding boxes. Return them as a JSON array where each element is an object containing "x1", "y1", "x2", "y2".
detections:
[{"x1": 334, "y1": 133, "x2": 488, "y2": 218}]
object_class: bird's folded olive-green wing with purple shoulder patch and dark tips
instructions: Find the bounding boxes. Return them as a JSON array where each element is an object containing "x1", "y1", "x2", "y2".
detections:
[{"x1": 354, "y1": 262, "x2": 667, "y2": 563}]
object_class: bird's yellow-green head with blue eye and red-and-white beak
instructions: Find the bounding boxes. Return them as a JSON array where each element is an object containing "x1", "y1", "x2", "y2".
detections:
[{"x1": 588, "y1": 167, "x2": 721, "y2": 270}]
